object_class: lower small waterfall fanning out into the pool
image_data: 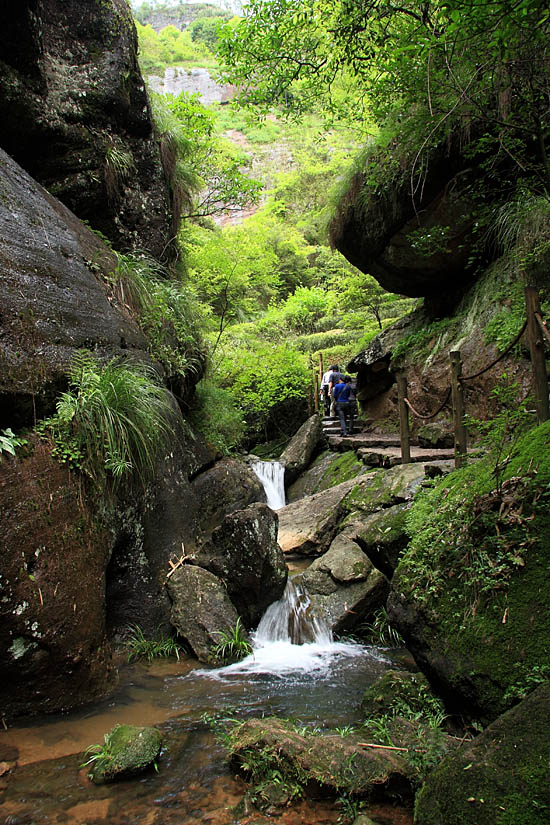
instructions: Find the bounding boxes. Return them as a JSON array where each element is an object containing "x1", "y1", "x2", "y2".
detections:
[{"x1": 254, "y1": 579, "x2": 332, "y2": 646}]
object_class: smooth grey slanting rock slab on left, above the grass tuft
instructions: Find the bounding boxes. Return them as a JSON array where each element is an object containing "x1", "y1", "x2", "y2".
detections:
[{"x1": 0, "y1": 150, "x2": 148, "y2": 428}]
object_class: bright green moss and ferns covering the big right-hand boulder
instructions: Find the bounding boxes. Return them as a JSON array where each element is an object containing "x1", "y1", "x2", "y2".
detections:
[{"x1": 400, "y1": 422, "x2": 550, "y2": 612}]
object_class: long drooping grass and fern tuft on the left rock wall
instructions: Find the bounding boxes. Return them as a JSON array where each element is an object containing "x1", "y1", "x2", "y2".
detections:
[{"x1": 40, "y1": 351, "x2": 172, "y2": 487}]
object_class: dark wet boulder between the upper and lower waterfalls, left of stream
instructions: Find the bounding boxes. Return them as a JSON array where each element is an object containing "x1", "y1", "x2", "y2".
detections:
[{"x1": 197, "y1": 504, "x2": 288, "y2": 627}]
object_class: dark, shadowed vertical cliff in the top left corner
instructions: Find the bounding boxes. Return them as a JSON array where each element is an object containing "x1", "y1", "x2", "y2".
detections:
[{"x1": 0, "y1": 0, "x2": 175, "y2": 259}]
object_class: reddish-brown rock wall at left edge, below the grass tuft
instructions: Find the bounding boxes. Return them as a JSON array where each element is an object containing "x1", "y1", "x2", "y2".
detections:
[{"x1": 0, "y1": 441, "x2": 115, "y2": 719}]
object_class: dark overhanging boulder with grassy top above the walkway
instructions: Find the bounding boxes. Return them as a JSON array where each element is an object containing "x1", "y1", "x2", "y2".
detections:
[{"x1": 330, "y1": 146, "x2": 473, "y2": 297}]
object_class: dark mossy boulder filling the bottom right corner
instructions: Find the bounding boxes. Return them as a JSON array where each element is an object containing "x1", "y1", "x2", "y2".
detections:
[{"x1": 414, "y1": 681, "x2": 550, "y2": 825}]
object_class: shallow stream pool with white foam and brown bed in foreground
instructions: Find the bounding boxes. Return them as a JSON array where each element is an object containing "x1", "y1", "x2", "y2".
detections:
[{"x1": 0, "y1": 642, "x2": 412, "y2": 825}]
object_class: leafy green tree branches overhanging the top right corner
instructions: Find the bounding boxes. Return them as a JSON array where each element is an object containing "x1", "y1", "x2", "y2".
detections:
[{"x1": 218, "y1": 0, "x2": 550, "y2": 189}]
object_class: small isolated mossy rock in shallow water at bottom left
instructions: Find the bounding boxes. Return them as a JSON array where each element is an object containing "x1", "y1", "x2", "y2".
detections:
[{"x1": 88, "y1": 725, "x2": 162, "y2": 785}]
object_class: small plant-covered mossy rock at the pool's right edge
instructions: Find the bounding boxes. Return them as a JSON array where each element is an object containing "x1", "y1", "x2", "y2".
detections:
[{"x1": 361, "y1": 670, "x2": 442, "y2": 719}]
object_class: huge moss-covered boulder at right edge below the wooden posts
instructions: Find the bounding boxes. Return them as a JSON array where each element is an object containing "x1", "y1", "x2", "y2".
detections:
[{"x1": 387, "y1": 422, "x2": 550, "y2": 722}]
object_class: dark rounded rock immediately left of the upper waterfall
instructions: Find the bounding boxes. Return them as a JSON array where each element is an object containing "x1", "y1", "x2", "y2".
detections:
[{"x1": 191, "y1": 458, "x2": 266, "y2": 544}]
